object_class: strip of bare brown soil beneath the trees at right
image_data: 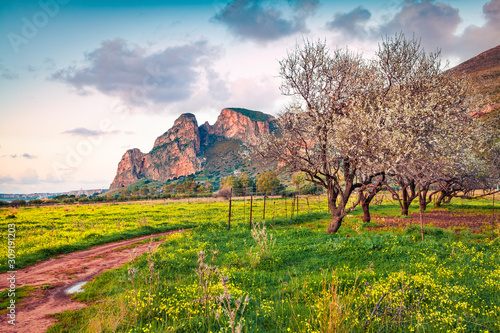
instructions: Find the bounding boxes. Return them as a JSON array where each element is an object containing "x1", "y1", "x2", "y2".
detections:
[{"x1": 368, "y1": 210, "x2": 492, "y2": 234}]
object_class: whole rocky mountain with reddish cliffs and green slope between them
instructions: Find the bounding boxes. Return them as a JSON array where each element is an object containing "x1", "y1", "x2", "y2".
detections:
[{"x1": 110, "y1": 108, "x2": 274, "y2": 190}]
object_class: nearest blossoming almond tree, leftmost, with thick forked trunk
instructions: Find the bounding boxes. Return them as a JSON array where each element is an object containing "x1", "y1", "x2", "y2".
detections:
[{"x1": 254, "y1": 42, "x2": 380, "y2": 233}]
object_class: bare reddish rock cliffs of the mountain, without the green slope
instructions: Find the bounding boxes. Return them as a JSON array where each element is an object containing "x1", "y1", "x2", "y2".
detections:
[{"x1": 110, "y1": 108, "x2": 274, "y2": 190}]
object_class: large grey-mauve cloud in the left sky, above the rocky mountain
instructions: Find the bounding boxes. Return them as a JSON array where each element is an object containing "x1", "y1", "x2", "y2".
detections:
[{"x1": 51, "y1": 38, "x2": 221, "y2": 106}]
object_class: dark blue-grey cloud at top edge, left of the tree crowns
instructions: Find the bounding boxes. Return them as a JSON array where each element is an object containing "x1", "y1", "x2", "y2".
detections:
[{"x1": 212, "y1": 0, "x2": 319, "y2": 42}]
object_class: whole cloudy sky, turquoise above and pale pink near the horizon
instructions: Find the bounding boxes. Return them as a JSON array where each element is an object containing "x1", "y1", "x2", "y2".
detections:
[{"x1": 0, "y1": 0, "x2": 500, "y2": 193}]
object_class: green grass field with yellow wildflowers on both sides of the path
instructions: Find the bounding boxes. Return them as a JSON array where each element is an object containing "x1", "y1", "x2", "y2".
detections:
[{"x1": 1, "y1": 198, "x2": 500, "y2": 332}]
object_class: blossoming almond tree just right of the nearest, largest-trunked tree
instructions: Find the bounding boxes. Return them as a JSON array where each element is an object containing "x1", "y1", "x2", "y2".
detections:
[{"x1": 376, "y1": 34, "x2": 477, "y2": 215}]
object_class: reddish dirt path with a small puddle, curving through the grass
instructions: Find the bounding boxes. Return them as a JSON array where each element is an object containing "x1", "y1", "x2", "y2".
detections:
[{"x1": 0, "y1": 229, "x2": 187, "y2": 333}]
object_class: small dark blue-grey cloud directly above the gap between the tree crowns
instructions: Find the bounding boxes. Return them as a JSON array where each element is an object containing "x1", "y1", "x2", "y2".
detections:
[{"x1": 326, "y1": 6, "x2": 372, "y2": 37}]
